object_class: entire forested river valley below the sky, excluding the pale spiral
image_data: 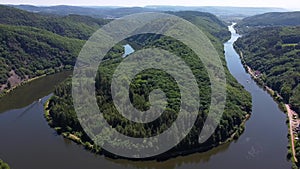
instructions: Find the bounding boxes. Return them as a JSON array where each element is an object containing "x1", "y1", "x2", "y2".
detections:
[{"x1": 0, "y1": 5, "x2": 300, "y2": 169}]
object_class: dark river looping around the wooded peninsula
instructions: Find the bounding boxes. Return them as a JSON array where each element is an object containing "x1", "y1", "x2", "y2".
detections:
[{"x1": 0, "y1": 26, "x2": 291, "y2": 169}]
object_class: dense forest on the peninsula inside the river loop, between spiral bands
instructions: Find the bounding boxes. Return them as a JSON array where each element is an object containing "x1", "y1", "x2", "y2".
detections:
[{"x1": 48, "y1": 12, "x2": 251, "y2": 158}]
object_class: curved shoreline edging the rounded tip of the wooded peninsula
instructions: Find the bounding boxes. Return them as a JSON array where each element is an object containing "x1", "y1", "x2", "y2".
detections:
[{"x1": 44, "y1": 98, "x2": 251, "y2": 162}]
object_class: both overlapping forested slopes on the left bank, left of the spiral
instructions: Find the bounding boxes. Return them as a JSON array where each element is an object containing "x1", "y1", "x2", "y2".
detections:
[{"x1": 0, "y1": 5, "x2": 109, "y2": 92}]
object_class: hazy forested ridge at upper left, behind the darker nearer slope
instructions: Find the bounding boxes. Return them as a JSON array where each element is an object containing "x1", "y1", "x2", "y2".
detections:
[{"x1": 0, "y1": 5, "x2": 109, "y2": 40}]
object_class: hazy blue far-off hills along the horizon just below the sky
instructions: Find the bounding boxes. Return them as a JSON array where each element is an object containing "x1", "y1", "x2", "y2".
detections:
[{"x1": 9, "y1": 5, "x2": 287, "y2": 18}]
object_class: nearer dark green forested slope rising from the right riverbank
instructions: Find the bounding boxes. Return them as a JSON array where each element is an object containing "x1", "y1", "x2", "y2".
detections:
[{"x1": 235, "y1": 26, "x2": 300, "y2": 113}]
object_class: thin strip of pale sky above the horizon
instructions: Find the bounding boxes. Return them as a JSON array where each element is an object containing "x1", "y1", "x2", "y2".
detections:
[{"x1": 0, "y1": 0, "x2": 300, "y2": 10}]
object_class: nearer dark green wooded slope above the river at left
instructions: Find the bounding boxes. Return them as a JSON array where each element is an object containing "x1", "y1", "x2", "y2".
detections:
[{"x1": 0, "y1": 24, "x2": 84, "y2": 84}]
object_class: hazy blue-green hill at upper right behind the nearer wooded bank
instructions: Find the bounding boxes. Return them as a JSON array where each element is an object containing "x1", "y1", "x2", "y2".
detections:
[{"x1": 236, "y1": 11, "x2": 300, "y2": 31}]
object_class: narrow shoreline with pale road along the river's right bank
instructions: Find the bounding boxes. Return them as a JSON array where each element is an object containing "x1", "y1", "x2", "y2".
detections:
[{"x1": 235, "y1": 48, "x2": 298, "y2": 166}]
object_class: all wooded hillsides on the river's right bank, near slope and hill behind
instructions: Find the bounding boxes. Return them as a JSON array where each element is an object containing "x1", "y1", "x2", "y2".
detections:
[{"x1": 235, "y1": 12, "x2": 300, "y2": 166}]
